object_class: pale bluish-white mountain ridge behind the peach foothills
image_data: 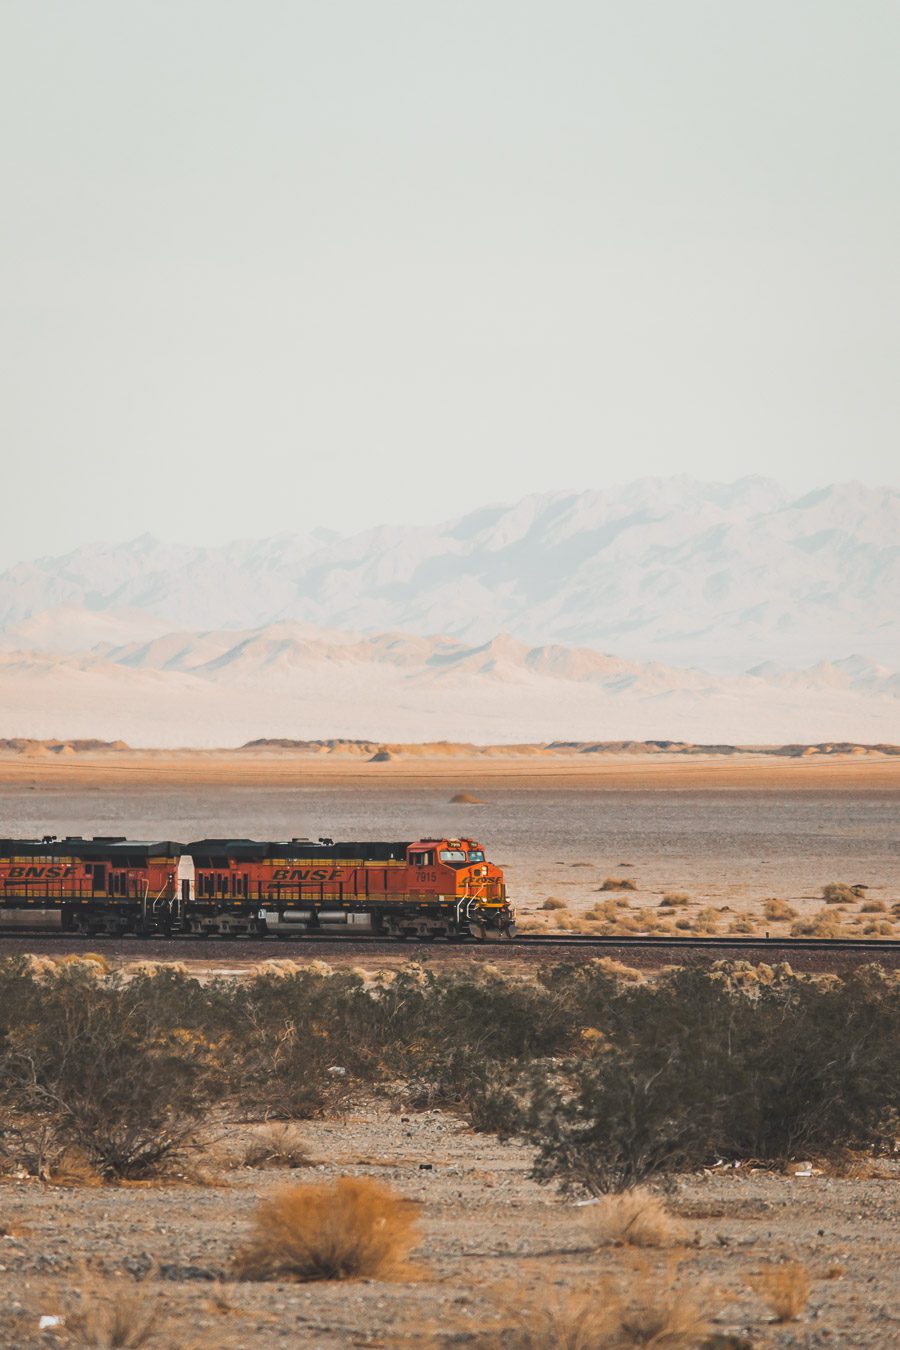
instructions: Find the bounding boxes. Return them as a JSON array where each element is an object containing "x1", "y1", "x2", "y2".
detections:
[{"x1": 0, "y1": 477, "x2": 900, "y2": 674}]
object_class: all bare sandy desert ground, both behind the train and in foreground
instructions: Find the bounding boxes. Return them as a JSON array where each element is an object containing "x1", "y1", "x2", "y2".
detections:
[{"x1": 0, "y1": 743, "x2": 900, "y2": 1350}]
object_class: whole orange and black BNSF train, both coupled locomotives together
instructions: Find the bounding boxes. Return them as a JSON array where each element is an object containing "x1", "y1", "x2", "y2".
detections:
[{"x1": 0, "y1": 834, "x2": 515, "y2": 941}]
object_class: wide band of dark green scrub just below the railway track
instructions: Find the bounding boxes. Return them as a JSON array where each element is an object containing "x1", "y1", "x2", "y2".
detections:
[{"x1": 0, "y1": 955, "x2": 900, "y2": 1195}]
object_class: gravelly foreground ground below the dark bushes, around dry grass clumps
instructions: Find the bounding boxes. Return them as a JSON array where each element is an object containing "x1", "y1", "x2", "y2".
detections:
[{"x1": 0, "y1": 1103, "x2": 900, "y2": 1350}]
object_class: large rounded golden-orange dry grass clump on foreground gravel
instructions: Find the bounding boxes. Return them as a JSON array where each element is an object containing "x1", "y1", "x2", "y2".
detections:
[{"x1": 233, "y1": 1177, "x2": 418, "y2": 1280}]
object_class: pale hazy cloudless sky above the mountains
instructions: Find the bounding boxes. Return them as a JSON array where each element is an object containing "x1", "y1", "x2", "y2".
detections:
[{"x1": 0, "y1": 0, "x2": 900, "y2": 563}]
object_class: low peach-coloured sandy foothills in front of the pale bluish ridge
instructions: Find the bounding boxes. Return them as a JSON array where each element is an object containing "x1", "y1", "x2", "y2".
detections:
[{"x1": 0, "y1": 622, "x2": 900, "y2": 745}]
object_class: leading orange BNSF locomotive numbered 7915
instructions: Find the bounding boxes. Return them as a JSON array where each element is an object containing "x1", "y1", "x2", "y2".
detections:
[{"x1": 179, "y1": 838, "x2": 514, "y2": 940}]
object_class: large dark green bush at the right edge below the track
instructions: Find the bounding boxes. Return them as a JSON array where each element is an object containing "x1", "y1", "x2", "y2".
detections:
[{"x1": 519, "y1": 968, "x2": 900, "y2": 1195}]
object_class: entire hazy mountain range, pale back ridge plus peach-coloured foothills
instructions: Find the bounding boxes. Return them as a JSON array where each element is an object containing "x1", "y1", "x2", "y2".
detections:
[{"x1": 0, "y1": 478, "x2": 900, "y2": 745}]
